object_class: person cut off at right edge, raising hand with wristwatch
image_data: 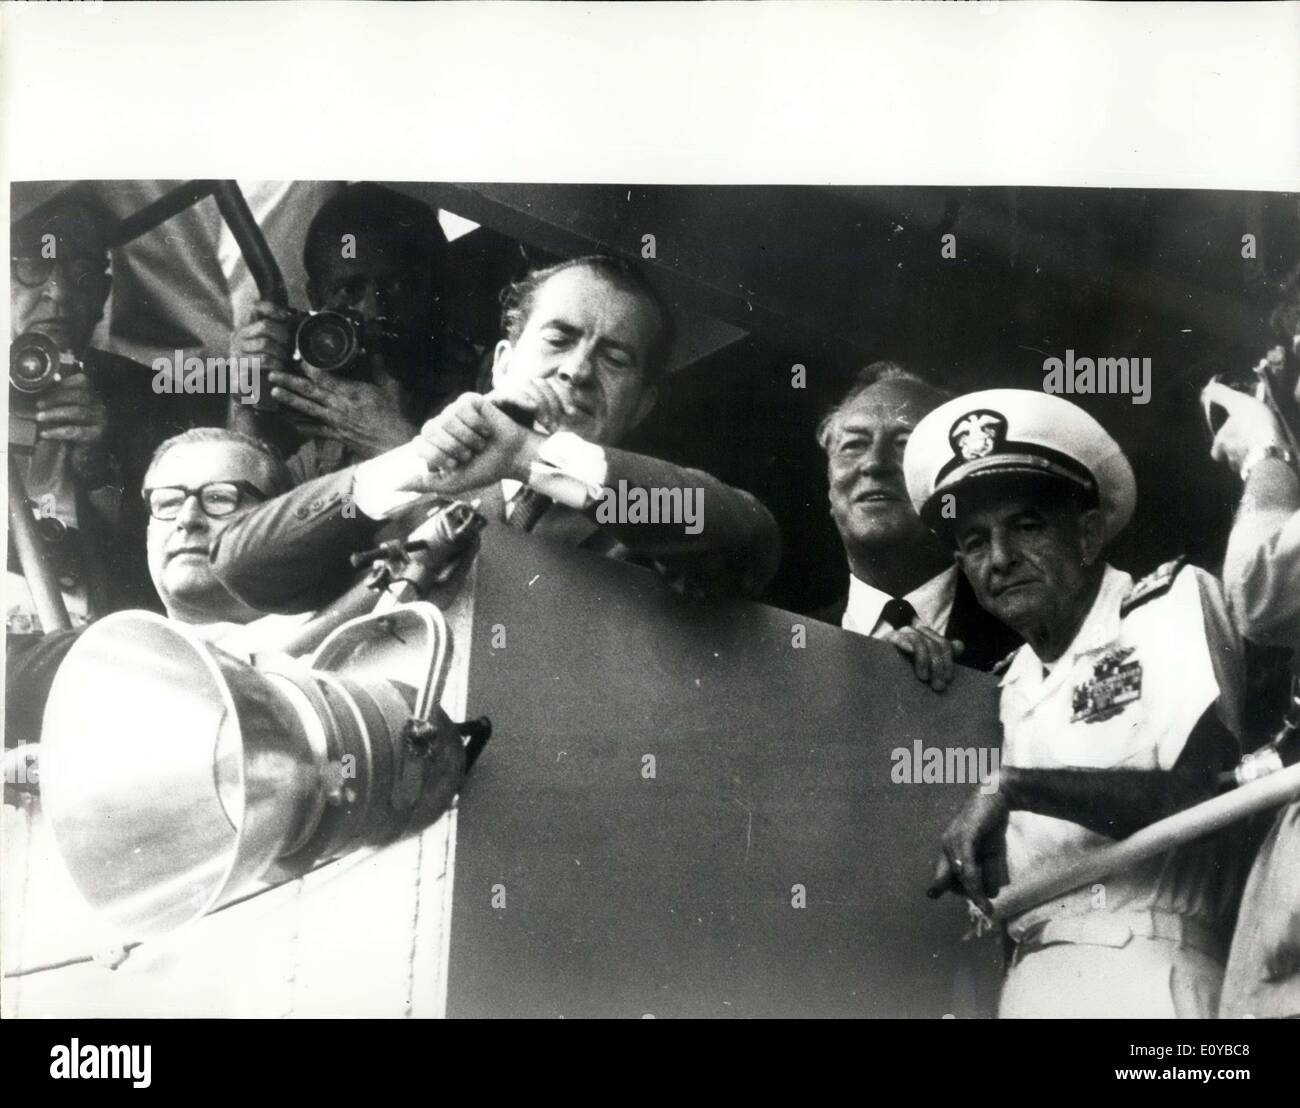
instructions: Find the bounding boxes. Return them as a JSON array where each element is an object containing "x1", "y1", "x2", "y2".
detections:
[{"x1": 1203, "y1": 382, "x2": 1300, "y2": 1017}]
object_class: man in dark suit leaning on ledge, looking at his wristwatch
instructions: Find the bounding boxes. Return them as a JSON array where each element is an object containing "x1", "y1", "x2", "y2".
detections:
[{"x1": 213, "y1": 256, "x2": 780, "y2": 611}]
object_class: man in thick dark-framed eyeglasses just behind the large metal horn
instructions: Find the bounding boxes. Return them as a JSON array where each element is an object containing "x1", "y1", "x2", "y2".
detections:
[{"x1": 5, "y1": 427, "x2": 299, "y2": 746}]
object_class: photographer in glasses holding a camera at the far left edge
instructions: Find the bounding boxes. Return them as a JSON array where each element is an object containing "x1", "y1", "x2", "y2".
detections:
[{"x1": 7, "y1": 192, "x2": 157, "y2": 632}]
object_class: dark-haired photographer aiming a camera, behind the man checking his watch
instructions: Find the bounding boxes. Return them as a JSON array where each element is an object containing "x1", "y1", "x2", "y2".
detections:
[{"x1": 228, "y1": 183, "x2": 475, "y2": 484}]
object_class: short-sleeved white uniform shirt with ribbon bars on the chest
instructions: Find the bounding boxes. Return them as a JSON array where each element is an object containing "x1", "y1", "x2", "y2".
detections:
[{"x1": 1000, "y1": 566, "x2": 1232, "y2": 939}]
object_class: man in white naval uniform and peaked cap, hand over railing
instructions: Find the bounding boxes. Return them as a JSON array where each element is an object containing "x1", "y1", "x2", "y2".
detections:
[{"x1": 905, "y1": 389, "x2": 1242, "y2": 1017}]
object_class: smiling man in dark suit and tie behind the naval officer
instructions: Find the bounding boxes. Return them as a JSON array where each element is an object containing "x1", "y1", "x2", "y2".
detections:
[{"x1": 816, "y1": 362, "x2": 1021, "y2": 691}]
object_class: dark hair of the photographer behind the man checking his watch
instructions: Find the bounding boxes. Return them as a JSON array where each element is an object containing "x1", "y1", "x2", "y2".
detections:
[{"x1": 303, "y1": 181, "x2": 447, "y2": 291}]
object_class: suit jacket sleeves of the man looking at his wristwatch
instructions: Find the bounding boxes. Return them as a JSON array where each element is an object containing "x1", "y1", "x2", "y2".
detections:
[{"x1": 212, "y1": 447, "x2": 780, "y2": 613}]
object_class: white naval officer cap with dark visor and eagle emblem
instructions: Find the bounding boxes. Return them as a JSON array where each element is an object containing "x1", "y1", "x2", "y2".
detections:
[{"x1": 904, "y1": 389, "x2": 1138, "y2": 542}]
